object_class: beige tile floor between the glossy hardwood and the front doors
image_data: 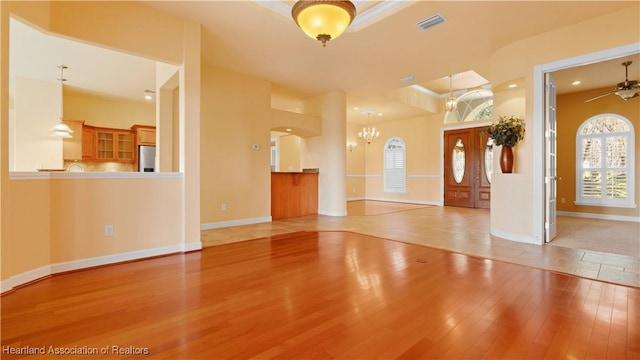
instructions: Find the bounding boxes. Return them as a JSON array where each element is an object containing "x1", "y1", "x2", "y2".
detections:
[{"x1": 201, "y1": 201, "x2": 640, "y2": 287}]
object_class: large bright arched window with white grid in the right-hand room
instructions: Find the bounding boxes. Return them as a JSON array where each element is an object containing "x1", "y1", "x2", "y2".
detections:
[{"x1": 576, "y1": 114, "x2": 635, "y2": 207}]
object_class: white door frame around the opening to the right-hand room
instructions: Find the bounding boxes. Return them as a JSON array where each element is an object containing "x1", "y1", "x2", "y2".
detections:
[{"x1": 533, "y1": 42, "x2": 640, "y2": 245}]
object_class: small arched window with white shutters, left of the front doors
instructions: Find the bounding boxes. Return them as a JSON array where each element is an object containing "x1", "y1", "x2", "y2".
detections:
[{"x1": 384, "y1": 137, "x2": 407, "y2": 193}]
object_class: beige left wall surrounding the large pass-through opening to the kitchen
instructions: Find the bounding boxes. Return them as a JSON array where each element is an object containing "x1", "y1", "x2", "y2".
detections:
[{"x1": 0, "y1": 1, "x2": 196, "y2": 291}]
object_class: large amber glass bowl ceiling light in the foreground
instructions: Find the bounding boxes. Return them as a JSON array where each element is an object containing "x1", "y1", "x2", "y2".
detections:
[{"x1": 291, "y1": 0, "x2": 356, "y2": 47}]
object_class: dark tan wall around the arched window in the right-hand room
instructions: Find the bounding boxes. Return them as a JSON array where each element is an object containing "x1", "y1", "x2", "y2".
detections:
[{"x1": 557, "y1": 89, "x2": 640, "y2": 218}]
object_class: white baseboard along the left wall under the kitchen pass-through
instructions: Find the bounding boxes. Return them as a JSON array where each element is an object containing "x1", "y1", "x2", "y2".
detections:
[{"x1": 0, "y1": 242, "x2": 202, "y2": 293}]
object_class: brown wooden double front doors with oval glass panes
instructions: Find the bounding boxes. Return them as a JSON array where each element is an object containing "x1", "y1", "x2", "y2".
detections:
[{"x1": 444, "y1": 126, "x2": 493, "y2": 209}]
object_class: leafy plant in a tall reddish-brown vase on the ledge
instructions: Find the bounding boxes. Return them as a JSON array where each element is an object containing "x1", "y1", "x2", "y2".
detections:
[{"x1": 487, "y1": 115, "x2": 525, "y2": 174}]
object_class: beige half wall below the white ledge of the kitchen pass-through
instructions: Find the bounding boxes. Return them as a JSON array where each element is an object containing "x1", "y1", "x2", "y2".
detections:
[{"x1": 2, "y1": 173, "x2": 183, "y2": 284}]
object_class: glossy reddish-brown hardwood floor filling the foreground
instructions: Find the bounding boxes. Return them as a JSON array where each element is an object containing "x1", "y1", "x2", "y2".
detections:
[{"x1": 1, "y1": 231, "x2": 640, "y2": 359}]
